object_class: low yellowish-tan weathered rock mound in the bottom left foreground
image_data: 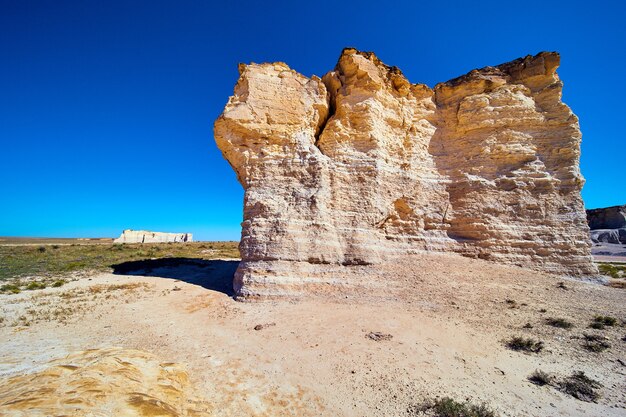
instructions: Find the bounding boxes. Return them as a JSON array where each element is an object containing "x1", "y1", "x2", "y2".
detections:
[{"x1": 0, "y1": 348, "x2": 213, "y2": 417}]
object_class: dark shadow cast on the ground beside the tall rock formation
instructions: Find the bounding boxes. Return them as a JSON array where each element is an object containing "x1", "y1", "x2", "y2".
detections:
[{"x1": 111, "y1": 258, "x2": 239, "y2": 297}]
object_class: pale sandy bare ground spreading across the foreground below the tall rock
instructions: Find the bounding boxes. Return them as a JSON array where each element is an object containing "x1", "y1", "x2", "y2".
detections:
[{"x1": 0, "y1": 255, "x2": 626, "y2": 416}]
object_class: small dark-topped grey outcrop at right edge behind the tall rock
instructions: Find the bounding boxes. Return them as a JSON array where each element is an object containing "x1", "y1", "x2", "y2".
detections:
[{"x1": 587, "y1": 205, "x2": 626, "y2": 244}]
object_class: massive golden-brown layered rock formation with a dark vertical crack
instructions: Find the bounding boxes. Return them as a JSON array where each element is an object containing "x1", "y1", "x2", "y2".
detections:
[{"x1": 215, "y1": 48, "x2": 597, "y2": 297}]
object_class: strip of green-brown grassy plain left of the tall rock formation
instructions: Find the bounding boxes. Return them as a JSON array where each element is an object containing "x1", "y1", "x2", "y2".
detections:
[{"x1": 0, "y1": 242, "x2": 239, "y2": 282}]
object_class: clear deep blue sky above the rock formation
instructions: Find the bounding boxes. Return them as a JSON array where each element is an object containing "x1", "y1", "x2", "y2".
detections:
[{"x1": 0, "y1": 0, "x2": 626, "y2": 240}]
